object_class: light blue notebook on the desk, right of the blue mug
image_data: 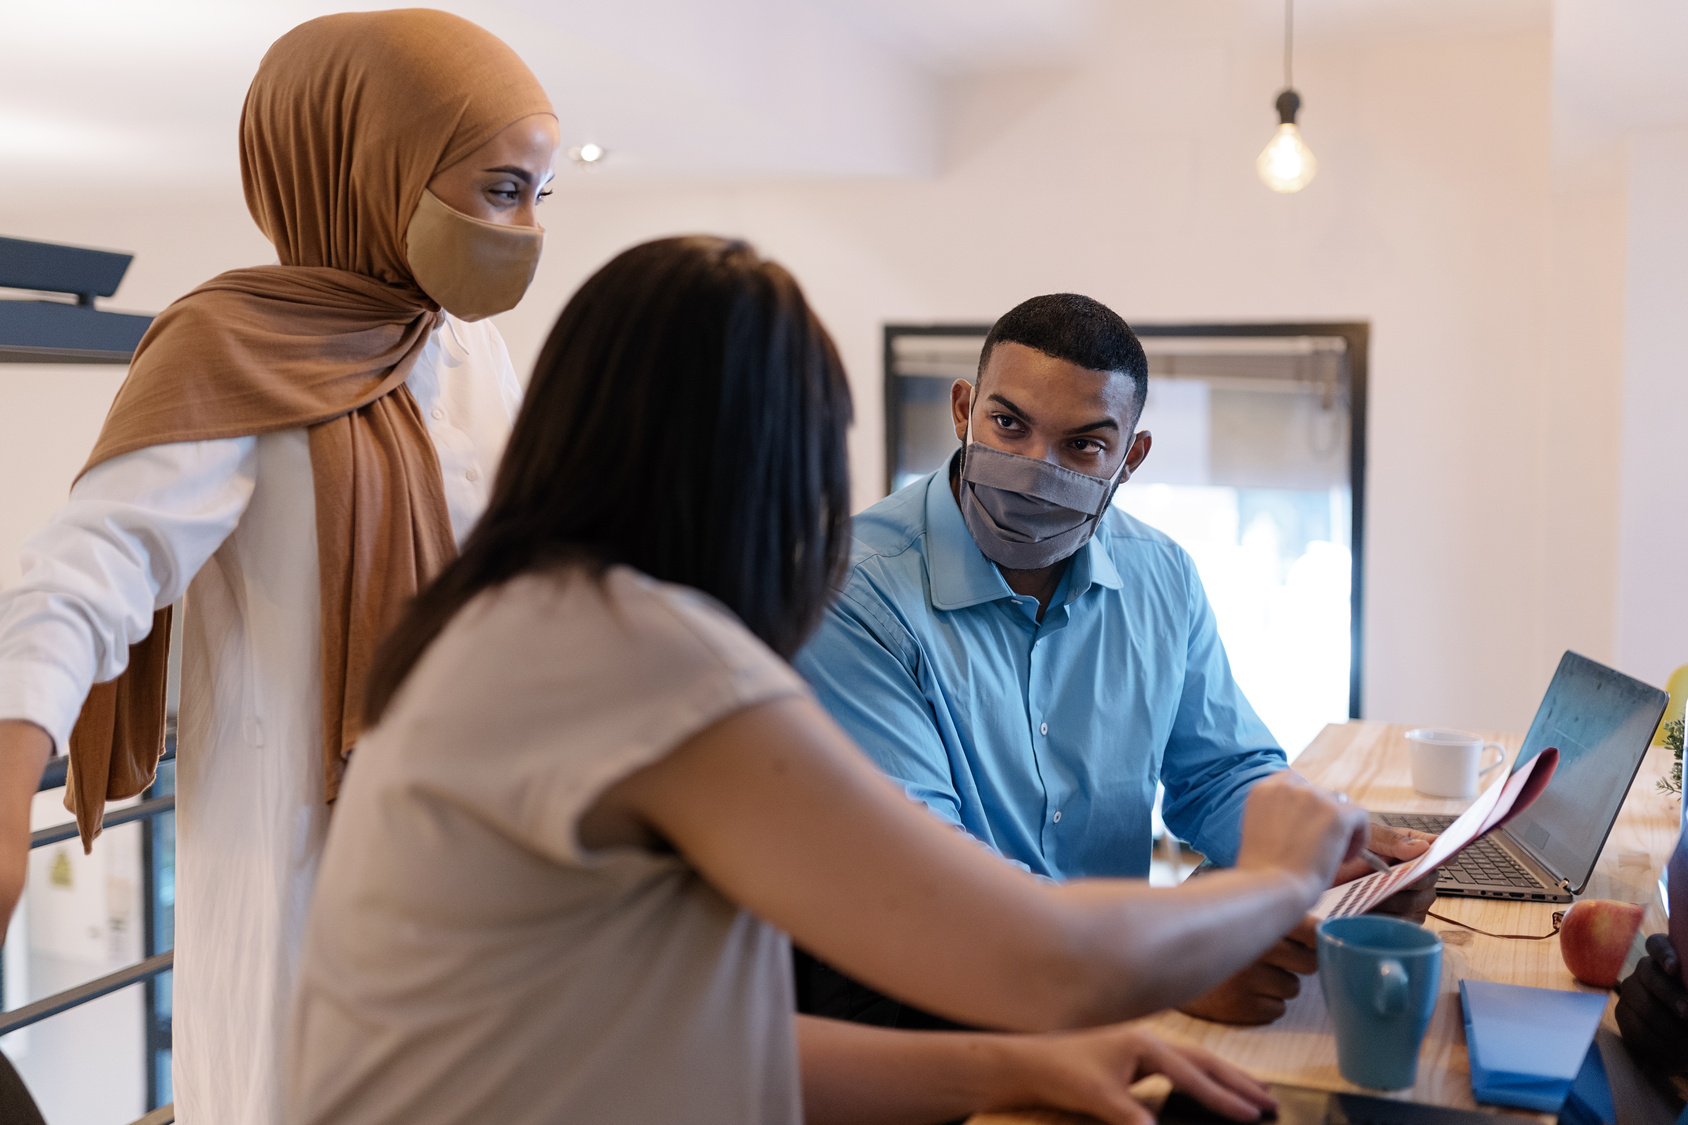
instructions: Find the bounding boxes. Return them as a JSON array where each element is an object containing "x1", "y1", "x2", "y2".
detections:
[{"x1": 1460, "y1": 980, "x2": 1607, "y2": 1113}]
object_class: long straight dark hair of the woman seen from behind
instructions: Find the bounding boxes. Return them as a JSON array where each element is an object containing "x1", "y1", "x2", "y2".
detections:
[{"x1": 365, "y1": 236, "x2": 851, "y2": 726}]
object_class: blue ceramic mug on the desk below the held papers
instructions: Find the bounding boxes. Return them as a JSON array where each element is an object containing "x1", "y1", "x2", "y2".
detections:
[{"x1": 1318, "y1": 914, "x2": 1442, "y2": 1090}]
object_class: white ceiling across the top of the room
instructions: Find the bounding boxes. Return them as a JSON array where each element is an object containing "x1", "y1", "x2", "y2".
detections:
[{"x1": 0, "y1": 0, "x2": 1688, "y2": 209}]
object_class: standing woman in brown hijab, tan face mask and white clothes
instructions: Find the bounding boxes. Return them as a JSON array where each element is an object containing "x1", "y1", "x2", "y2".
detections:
[{"x1": 0, "y1": 10, "x2": 559, "y2": 1125}]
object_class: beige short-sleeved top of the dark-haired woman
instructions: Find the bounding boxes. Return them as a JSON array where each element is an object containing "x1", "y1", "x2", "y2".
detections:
[{"x1": 287, "y1": 568, "x2": 805, "y2": 1125}]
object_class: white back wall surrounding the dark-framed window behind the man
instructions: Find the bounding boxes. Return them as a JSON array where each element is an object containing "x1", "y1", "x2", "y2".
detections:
[{"x1": 0, "y1": 3, "x2": 1660, "y2": 730}]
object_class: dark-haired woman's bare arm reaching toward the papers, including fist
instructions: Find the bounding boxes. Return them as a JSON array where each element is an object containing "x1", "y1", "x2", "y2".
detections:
[{"x1": 581, "y1": 699, "x2": 1366, "y2": 1030}]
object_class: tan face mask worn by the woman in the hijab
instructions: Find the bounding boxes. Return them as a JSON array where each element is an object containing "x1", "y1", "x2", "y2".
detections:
[{"x1": 405, "y1": 189, "x2": 545, "y2": 321}]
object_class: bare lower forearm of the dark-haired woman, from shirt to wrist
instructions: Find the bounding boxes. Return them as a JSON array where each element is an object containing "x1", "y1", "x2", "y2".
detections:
[{"x1": 797, "y1": 1015, "x2": 1014, "y2": 1125}]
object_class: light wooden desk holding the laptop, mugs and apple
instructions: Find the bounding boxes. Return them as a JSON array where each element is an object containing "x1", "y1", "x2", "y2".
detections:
[{"x1": 972, "y1": 721, "x2": 1678, "y2": 1125}]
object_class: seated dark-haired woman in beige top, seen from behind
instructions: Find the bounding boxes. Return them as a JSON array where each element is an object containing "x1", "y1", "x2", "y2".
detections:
[{"x1": 289, "y1": 238, "x2": 1366, "y2": 1125}]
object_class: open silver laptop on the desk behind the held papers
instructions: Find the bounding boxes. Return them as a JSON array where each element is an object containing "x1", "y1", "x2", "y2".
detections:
[{"x1": 1372, "y1": 652, "x2": 1669, "y2": 902}]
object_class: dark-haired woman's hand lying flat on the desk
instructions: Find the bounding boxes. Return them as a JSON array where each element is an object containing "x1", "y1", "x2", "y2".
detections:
[{"x1": 993, "y1": 1024, "x2": 1278, "y2": 1125}]
